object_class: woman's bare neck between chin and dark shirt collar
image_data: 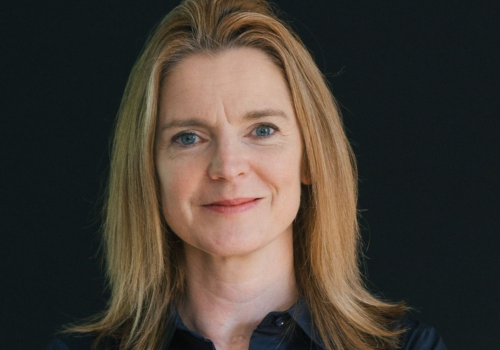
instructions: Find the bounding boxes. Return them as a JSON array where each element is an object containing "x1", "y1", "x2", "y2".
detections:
[{"x1": 178, "y1": 230, "x2": 298, "y2": 350}]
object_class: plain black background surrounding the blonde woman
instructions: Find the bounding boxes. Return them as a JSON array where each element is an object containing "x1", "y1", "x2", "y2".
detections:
[{"x1": 0, "y1": 0, "x2": 500, "y2": 350}]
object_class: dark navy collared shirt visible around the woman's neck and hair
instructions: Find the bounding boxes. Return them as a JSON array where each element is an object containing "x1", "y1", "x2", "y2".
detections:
[{"x1": 46, "y1": 302, "x2": 446, "y2": 350}]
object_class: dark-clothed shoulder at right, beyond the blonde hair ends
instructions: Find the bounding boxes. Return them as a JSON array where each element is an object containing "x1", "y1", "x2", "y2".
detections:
[{"x1": 402, "y1": 319, "x2": 446, "y2": 350}]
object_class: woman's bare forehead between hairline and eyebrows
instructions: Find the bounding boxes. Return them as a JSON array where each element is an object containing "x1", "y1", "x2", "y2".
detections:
[{"x1": 160, "y1": 48, "x2": 294, "y2": 118}]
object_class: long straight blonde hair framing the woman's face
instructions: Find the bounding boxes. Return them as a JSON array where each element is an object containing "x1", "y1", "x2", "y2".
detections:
[{"x1": 73, "y1": 0, "x2": 406, "y2": 350}]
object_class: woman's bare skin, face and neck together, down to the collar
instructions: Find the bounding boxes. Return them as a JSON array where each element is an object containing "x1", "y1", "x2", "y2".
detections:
[{"x1": 155, "y1": 48, "x2": 307, "y2": 349}]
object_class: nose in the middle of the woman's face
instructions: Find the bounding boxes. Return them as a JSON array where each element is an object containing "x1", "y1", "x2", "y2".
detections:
[{"x1": 208, "y1": 140, "x2": 250, "y2": 181}]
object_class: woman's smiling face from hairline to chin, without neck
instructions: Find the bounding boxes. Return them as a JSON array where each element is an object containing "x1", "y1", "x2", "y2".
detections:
[{"x1": 155, "y1": 48, "x2": 302, "y2": 257}]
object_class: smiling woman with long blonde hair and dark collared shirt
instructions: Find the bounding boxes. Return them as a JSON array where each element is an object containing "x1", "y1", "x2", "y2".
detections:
[{"x1": 47, "y1": 0, "x2": 445, "y2": 350}]
